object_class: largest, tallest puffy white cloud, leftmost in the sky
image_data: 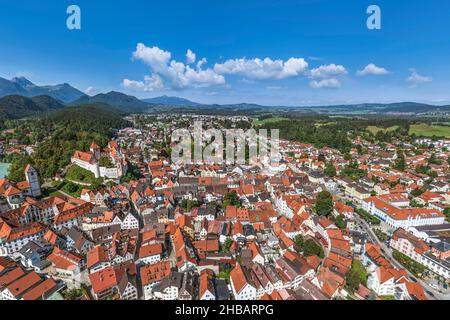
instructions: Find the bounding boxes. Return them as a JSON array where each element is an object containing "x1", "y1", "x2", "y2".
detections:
[{"x1": 122, "y1": 43, "x2": 225, "y2": 91}]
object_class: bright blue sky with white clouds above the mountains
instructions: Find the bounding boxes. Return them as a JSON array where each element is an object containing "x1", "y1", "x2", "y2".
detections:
[{"x1": 0, "y1": 0, "x2": 450, "y2": 105}]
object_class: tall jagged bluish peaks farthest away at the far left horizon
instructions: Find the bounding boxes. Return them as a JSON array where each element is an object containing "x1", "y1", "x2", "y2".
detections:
[{"x1": 0, "y1": 77, "x2": 86, "y2": 103}]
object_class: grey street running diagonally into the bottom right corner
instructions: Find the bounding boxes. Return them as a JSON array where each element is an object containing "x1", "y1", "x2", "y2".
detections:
[{"x1": 354, "y1": 214, "x2": 450, "y2": 300}]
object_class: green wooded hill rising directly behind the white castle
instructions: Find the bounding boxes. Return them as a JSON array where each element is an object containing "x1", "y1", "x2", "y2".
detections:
[{"x1": 5, "y1": 105, "x2": 131, "y2": 181}]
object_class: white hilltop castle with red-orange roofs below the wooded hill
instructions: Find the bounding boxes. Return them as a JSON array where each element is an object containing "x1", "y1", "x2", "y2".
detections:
[{"x1": 71, "y1": 141, "x2": 127, "y2": 179}]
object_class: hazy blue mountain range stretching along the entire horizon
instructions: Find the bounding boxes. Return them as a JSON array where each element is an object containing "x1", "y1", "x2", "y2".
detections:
[{"x1": 0, "y1": 77, "x2": 450, "y2": 119}]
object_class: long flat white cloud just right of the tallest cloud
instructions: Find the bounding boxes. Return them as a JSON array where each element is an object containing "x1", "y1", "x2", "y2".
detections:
[{"x1": 214, "y1": 58, "x2": 308, "y2": 80}]
